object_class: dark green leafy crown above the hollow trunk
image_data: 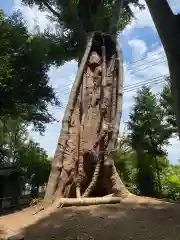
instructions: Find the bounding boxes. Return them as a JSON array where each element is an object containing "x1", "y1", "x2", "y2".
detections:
[{"x1": 22, "y1": 0, "x2": 143, "y2": 63}]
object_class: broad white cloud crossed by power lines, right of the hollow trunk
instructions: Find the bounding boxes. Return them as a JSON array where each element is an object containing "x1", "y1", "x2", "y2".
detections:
[{"x1": 124, "y1": 44, "x2": 168, "y2": 109}]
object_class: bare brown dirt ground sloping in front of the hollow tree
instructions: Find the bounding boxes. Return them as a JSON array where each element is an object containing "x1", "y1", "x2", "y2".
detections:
[{"x1": 0, "y1": 197, "x2": 180, "y2": 240}]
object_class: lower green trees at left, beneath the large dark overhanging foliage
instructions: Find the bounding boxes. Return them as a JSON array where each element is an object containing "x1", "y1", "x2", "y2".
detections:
[{"x1": 0, "y1": 115, "x2": 51, "y2": 200}]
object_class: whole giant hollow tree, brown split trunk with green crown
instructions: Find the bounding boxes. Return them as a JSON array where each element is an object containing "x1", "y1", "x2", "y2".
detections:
[{"x1": 23, "y1": 0, "x2": 145, "y2": 206}]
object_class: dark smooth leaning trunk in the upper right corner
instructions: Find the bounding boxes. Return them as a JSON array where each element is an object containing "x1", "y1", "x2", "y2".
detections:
[{"x1": 146, "y1": 0, "x2": 180, "y2": 138}]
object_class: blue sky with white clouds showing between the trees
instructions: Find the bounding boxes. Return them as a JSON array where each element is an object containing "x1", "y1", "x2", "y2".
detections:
[{"x1": 0, "y1": 0, "x2": 180, "y2": 164}]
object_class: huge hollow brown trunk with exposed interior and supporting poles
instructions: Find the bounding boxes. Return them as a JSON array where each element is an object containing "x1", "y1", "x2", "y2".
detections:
[{"x1": 44, "y1": 33, "x2": 129, "y2": 207}]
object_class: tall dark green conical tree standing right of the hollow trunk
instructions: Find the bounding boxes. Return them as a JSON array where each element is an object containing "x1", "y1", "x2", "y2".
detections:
[{"x1": 128, "y1": 87, "x2": 170, "y2": 196}]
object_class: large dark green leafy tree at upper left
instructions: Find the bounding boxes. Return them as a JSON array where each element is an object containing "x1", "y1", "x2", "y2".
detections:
[{"x1": 0, "y1": 12, "x2": 59, "y2": 131}]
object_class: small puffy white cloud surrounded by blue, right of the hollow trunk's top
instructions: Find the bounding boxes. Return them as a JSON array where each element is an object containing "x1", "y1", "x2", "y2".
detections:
[{"x1": 128, "y1": 39, "x2": 147, "y2": 61}]
